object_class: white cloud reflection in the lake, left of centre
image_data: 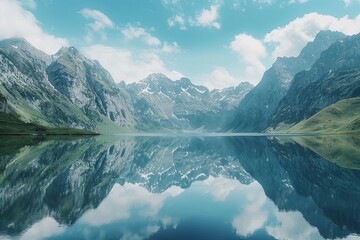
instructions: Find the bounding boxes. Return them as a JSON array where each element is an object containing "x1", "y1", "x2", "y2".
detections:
[{"x1": 79, "y1": 183, "x2": 183, "y2": 239}]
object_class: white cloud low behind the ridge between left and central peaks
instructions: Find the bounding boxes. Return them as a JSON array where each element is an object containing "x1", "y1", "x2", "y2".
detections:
[{"x1": 84, "y1": 45, "x2": 183, "y2": 83}]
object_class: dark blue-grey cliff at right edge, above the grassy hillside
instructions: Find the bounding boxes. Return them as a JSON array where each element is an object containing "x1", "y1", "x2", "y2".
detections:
[{"x1": 270, "y1": 35, "x2": 360, "y2": 129}]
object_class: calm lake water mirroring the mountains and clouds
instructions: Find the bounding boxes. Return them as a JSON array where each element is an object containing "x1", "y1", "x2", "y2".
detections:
[{"x1": 0, "y1": 136, "x2": 360, "y2": 239}]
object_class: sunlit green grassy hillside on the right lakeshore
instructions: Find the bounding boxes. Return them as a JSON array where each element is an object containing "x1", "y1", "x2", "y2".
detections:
[{"x1": 289, "y1": 97, "x2": 360, "y2": 133}]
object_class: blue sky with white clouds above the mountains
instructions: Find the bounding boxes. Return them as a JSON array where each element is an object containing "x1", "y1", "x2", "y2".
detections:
[{"x1": 0, "y1": 0, "x2": 360, "y2": 88}]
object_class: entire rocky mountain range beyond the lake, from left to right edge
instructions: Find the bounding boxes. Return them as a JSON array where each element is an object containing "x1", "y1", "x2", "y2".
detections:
[{"x1": 0, "y1": 31, "x2": 360, "y2": 133}]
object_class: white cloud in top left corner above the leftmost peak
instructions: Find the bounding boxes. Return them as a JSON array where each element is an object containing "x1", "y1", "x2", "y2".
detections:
[{"x1": 0, "y1": 0, "x2": 68, "y2": 54}]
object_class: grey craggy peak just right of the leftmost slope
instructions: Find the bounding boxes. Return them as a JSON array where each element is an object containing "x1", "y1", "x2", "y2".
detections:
[{"x1": 46, "y1": 47, "x2": 135, "y2": 127}]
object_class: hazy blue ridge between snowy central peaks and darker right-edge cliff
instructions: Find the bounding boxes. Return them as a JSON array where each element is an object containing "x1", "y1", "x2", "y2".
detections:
[{"x1": 225, "y1": 31, "x2": 344, "y2": 132}]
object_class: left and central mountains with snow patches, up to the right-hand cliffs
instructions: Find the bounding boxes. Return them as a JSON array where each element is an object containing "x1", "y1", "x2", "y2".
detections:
[{"x1": 0, "y1": 39, "x2": 253, "y2": 132}]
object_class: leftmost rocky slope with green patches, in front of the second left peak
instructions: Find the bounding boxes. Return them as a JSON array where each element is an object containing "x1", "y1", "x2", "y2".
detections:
[{"x1": 0, "y1": 43, "x2": 95, "y2": 129}]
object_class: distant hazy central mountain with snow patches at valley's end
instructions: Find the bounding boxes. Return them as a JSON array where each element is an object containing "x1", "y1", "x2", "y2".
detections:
[{"x1": 126, "y1": 74, "x2": 253, "y2": 130}]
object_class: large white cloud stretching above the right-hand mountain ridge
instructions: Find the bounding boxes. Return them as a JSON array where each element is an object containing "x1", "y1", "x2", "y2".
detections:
[{"x1": 230, "y1": 12, "x2": 360, "y2": 84}]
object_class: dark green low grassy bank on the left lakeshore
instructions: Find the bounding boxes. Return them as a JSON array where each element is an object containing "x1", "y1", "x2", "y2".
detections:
[{"x1": 0, "y1": 113, "x2": 97, "y2": 135}]
